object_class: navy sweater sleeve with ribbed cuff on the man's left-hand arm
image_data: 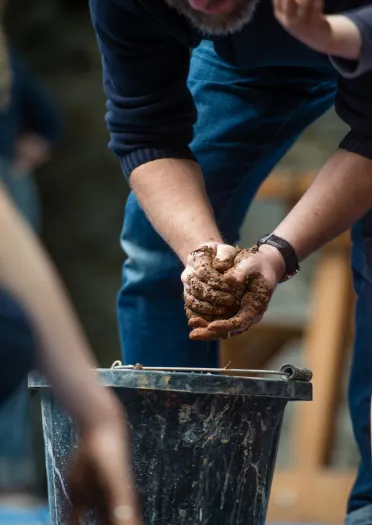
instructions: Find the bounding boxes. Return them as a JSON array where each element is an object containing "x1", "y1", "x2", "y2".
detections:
[{"x1": 89, "y1": 0, "x2": 196, "y2": 178}]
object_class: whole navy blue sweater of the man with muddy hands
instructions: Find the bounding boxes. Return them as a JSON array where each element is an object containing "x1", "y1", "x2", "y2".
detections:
[{"x1": 90, "y1": 0, "x2": 372, "y2": 177}]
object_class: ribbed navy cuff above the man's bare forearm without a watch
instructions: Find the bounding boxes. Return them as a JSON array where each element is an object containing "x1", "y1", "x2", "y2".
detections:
[{"x1": 121, "y1": 147, "x2": 196, "y2": 180}]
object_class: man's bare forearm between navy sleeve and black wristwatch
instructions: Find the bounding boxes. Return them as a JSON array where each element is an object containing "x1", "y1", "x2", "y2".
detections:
[{"x1": 274, "y1": 150, "x2": 372, "y2": 260}]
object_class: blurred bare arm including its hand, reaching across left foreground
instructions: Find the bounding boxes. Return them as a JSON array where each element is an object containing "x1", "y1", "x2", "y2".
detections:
[{"x1": 0, "y1": 182, "x2": 138, "y2": 525}]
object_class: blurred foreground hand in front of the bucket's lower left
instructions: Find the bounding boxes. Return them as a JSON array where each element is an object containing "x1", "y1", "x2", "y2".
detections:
[{"x1": 68, "y1": 412, "x2": 141, "y2": 525}]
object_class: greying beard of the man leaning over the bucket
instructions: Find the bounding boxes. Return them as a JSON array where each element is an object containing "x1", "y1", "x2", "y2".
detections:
[{"x1": 165, "y1": 0, "x2": 259, "y2": 36}]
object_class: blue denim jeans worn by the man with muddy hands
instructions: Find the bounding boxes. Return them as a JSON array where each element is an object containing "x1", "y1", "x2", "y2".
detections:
[{"x1": 118, "y1": 42, "x2": 372, "y2": 520}]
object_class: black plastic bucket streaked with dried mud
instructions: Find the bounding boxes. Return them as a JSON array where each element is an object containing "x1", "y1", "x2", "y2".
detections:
[{"x1": 29, "y1": 368, "x2": 312, "y2": 525}]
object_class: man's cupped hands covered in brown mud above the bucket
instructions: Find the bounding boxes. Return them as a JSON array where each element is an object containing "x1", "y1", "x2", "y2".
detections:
[{"x1": 182, "y1": 244, "x2": 275, "y2": 340}]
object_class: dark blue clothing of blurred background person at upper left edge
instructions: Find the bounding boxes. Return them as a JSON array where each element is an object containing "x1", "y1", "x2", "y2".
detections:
[{"x1": 0, "y1": 50, "x2": 61, "y2": 159}]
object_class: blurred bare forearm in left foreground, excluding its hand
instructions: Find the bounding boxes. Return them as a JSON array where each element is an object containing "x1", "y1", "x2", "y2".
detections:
[{"x1": 0, "y1": 187, "x2": 116, "y2": 427}]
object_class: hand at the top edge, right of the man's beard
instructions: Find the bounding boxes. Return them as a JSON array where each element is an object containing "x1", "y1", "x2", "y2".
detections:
[{"x1": 273, "y1": 0, "x2": 332, "y2": 52}]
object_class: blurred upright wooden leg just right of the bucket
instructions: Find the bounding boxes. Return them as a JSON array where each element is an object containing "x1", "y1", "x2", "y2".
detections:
[{"x1": 293, "y1": 250, "x2": 353, "y2": 469}]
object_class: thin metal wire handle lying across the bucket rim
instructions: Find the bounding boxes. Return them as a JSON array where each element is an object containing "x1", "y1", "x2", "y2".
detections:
[{"x1": 111, "y1": 361, "x2": 313, "y2": 382}]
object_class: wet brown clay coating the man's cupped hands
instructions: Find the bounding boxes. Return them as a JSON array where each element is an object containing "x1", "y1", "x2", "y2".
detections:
[{"x1": 185, "y1": 246, "x2": 271, "y2": 340}]
